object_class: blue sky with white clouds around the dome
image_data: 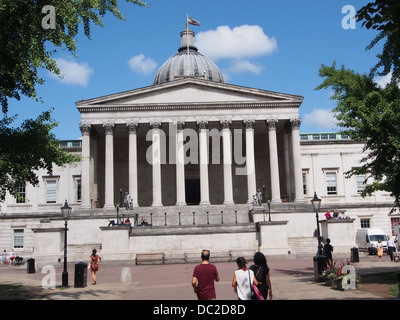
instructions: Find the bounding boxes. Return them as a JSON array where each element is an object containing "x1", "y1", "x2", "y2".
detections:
[{"x1": 9, "y1": 0, "x2": 380, "y2": 140}]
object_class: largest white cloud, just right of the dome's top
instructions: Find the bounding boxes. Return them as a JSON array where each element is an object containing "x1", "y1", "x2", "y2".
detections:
[{"x1": 196, "y1": 25, "x2": 278, "y2": 61}]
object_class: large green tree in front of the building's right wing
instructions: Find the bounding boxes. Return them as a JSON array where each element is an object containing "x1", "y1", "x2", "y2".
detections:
[{"x1": 316, "y1": 64, "x2": 400, "y2": 211}]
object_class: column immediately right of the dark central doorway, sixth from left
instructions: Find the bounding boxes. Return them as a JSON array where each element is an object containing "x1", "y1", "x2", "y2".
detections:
[{"x1": 197, "y1": 121, "x2": 210, "y2": 205}]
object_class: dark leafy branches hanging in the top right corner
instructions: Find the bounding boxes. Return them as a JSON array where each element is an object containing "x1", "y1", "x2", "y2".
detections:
[{"x1": 356, "y1": 0, "x2": 400, "y2": 82}]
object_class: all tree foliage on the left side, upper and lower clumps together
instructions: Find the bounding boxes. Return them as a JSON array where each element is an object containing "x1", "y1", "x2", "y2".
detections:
[{"x1": 0, "y1": 0, "x2": 147, "y2": 201}]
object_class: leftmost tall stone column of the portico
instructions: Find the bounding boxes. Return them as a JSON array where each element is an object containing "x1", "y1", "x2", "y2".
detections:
[{"x1": 79, "y1": 124, "x2": 90, "y2": 209}]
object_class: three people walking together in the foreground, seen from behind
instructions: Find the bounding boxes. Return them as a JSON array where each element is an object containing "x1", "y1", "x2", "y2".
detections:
[{"x1": 192, "y1": 250, "x2": 272, "y2": 300}]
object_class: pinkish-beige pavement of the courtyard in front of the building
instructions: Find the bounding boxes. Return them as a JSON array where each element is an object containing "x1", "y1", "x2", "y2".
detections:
[{"x1": 0, "y1": 256, "x2": 400, "y2": 301}]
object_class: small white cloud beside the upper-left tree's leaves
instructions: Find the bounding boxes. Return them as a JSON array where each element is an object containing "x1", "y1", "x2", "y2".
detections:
[{"x1": 50, "y1": 58, "x2": 94, "y2": 87}]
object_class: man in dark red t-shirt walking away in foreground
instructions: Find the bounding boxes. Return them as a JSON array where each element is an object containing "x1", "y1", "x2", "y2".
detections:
[{"x1": 192, "y1": 250, "x2": 219, "y2": 300}]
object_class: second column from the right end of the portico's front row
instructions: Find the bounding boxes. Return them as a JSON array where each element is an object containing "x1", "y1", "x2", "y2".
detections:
[{"x1": 266, "y1": 120, "x2": 281, "y2": 202}]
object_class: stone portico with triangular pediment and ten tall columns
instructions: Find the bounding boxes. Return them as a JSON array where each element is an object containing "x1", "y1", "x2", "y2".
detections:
[{"x1": 77, "y1": 77, "x2": 304, "y2": 209}]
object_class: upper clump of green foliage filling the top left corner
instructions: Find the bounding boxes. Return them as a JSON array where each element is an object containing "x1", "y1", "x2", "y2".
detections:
[{"x1": 0, "y1": 0, "x2": 147, "y2": 113}]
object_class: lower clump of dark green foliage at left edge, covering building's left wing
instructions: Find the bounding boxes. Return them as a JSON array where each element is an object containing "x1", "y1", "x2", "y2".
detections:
[{"x1": 0, "y1": 110, "x2": 80, "y2": 201}]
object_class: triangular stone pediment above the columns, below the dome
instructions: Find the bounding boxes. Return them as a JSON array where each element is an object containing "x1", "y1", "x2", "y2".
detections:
[{"x1": 76, "y1": 78, "x2": 303, "y2": 108}]
